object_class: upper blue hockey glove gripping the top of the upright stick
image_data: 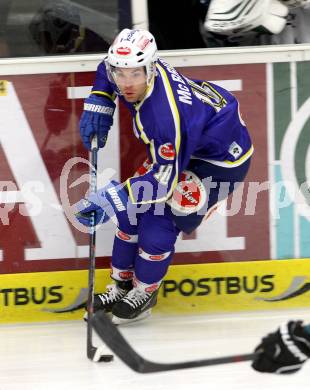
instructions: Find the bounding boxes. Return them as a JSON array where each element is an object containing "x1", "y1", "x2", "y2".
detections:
[{"x1": 80, "y1": 95, "x2": 115, "y2": 150}]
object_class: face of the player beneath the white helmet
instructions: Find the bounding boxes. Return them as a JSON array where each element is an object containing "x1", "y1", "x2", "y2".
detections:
[{"x1": 113, "y1": 66, "x2": 147, "y2": 103}]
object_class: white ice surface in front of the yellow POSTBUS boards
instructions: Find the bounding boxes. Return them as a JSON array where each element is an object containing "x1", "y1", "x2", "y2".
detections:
[{"x1": 0, "y1": 310, "x2": 310, "y2": 390}]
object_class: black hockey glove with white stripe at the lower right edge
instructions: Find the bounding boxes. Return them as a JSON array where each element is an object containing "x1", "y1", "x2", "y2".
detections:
[{"x1": 252, "y1": 321, "x2": 310, "y2": 374}]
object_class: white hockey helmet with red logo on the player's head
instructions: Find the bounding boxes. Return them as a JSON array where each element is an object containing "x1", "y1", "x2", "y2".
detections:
[{"x1": 106, "y1": 28, "x2": 157, "y2": 84}]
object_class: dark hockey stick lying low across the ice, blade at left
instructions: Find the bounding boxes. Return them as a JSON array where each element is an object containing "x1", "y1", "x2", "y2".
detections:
[{"x1": 91, "y1": 311, "x2": 255, "y2": 374}]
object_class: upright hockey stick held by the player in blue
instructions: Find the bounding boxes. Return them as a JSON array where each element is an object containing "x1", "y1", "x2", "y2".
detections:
[{"x1": 87, "y1": 136, "x2": 113, "y2": 362}]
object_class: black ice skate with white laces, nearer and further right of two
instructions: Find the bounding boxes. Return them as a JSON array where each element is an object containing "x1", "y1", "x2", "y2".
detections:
[{"x1": 112, "y1": 283, "x2": 159, "y2": 324}]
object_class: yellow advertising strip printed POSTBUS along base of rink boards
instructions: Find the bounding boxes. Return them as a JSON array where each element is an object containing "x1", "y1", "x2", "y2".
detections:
[{"x1": 0, "y1": 259, "x2": 310, "y2": 323}]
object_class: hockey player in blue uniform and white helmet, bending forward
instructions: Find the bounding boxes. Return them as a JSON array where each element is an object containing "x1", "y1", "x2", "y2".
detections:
[{"x1": 77, "y1": 29, "x2": 253, "y2": 322}]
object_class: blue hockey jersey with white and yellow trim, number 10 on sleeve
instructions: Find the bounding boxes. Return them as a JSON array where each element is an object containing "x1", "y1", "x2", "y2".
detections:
[{"x1": 92, "y1": 59, "x2": 253, "y2": 204}]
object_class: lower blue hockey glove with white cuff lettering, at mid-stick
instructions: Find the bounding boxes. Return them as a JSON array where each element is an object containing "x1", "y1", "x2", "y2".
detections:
[{"x1": 75, "y1": 180, "x2": 128, "y2": 226}]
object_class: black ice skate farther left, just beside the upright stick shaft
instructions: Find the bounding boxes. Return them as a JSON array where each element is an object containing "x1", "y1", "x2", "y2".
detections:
[{"x1": 84, "y1": 280, "x2": 133, "y2": 320}]
